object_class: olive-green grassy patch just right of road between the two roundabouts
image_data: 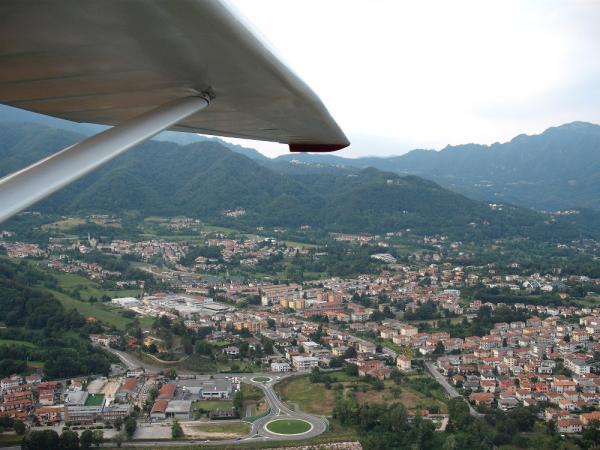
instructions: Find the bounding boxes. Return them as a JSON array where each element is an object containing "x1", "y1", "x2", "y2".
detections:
[{"x1": 275, "y1": 376, "x2": 335, "y2": 415}]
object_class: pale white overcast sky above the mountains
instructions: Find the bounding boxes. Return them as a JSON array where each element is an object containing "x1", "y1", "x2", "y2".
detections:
[{"x1": 219, "y1": 0, "x2": 600, "y2": 156}]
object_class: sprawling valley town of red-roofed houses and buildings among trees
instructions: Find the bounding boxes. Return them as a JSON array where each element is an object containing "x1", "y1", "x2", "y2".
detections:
[{"x1": 0, "y1": 216, "x2": 600, "y2": 446}]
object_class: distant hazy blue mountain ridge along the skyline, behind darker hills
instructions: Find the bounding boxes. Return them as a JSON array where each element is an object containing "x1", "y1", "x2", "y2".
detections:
[{"x1": 0, "y1": 105, "x2": 600, "y2": 211}]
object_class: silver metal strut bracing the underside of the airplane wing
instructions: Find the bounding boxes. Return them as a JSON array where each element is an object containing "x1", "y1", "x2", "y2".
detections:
[{"x1": 0, "y1": 97, "x2": 209, "y2": 222}]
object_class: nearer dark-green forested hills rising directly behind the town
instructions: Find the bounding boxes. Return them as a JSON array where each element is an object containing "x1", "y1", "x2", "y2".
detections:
[{"x1": 0, "y1": 119, "x2": 598, "y2": 239}]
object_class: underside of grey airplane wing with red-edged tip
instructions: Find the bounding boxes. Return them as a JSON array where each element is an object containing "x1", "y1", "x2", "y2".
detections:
[{"x1": 0, "y1": 0, "x2": 349, "y2": 151}]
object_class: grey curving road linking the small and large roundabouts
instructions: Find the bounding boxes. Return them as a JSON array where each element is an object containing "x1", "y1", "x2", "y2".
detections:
[{"x1": 107, "y1": 349, "x2": 328, "y2": 447}]
